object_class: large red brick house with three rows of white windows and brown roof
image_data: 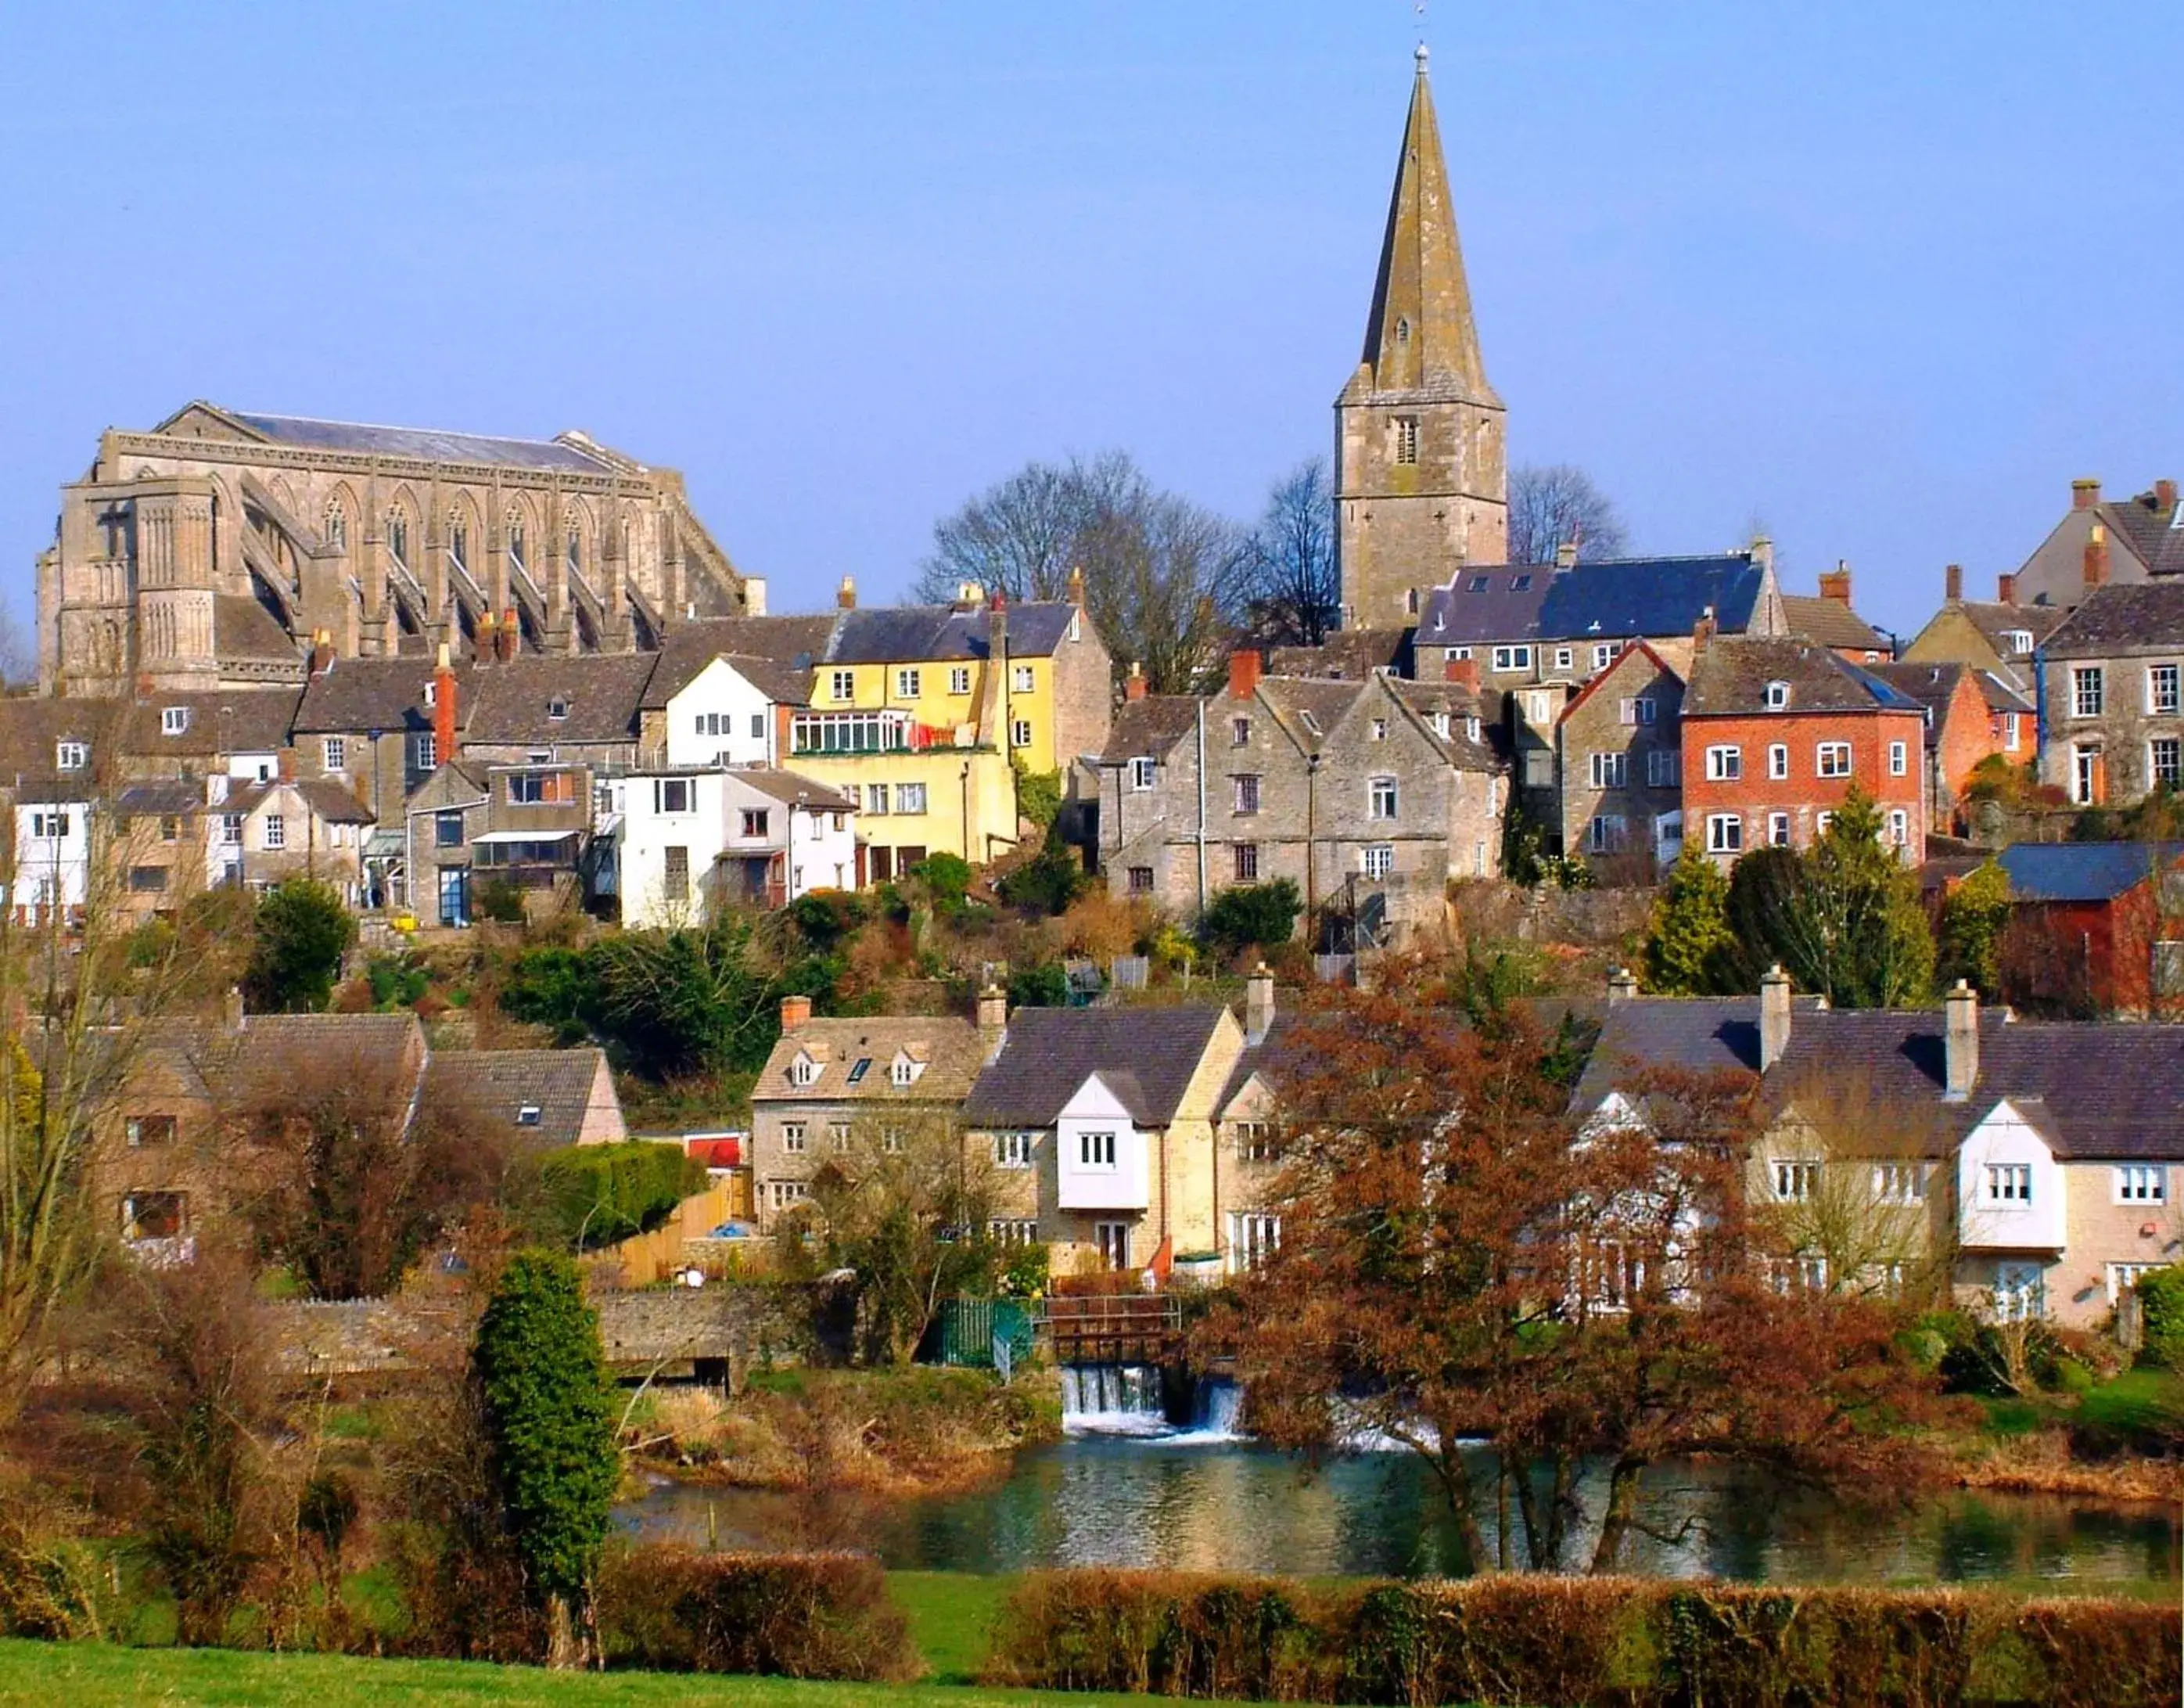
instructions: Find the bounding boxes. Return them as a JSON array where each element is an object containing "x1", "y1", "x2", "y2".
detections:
[{"x1": 1684, "y1": 624, "x2": 1927, "y2": 865}]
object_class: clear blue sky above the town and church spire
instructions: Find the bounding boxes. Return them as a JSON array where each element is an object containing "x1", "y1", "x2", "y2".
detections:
[{"x1": 0, "y1": 0, "x2": 2184, "y2": 631}]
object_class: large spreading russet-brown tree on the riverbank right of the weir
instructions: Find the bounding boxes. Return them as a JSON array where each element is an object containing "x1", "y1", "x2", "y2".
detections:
[{"x1": 1203, "y1": 965, "x2": 1924, "y2": 1573}]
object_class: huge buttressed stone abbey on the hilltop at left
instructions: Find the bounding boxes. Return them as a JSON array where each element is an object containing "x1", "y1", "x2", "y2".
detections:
[{"x1": 37, "y1": 402, "x2": 764, "y2": 695}]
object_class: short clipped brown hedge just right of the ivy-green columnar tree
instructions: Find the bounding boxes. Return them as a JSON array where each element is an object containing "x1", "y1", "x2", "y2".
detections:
[{"x1": 598, "y1": 1546, "x2": 919, "y2": 1682}]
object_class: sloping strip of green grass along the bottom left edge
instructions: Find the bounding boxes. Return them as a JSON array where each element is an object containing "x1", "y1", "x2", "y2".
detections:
[{"x1": 0, "y1": 1638, "x2": 1231, "y2": 1708}]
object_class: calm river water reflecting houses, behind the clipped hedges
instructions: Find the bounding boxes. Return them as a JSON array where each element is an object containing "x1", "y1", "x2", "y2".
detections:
[{"x1": 620, "y1": 1437, "x2": 2184, "y2": 1584}]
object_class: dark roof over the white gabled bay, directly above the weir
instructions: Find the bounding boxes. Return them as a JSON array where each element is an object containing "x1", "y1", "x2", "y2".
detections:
[{"x1": 963, "y1": 1005, "x2": 1227, "y2": 1127}]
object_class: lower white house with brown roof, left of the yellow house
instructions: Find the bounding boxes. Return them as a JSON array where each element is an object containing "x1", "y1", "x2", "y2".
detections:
[{"x1": 614, "y1": 764, "x2": 856, "y2": 928}]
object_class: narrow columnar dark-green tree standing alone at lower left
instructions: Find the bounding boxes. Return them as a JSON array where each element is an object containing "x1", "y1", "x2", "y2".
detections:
[{"x1": 472, "y1": 1252, "x2": 623, "y2": 1664}]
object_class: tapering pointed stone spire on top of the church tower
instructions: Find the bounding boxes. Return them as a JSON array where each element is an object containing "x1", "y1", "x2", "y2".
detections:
[{"x1": 1359, "y1": 44, "x2": 1500, "y2": 404}]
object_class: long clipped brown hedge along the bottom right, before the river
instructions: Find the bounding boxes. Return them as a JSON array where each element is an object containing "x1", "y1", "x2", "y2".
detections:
[{"x1": 987, "y1": 1570, "x2": 2184, "y2": 1708}]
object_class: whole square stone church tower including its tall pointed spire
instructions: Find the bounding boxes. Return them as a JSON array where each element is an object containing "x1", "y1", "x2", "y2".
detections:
[{"x1": 1334, "y1": 46, "x2": 1509, "y2": 629}]
